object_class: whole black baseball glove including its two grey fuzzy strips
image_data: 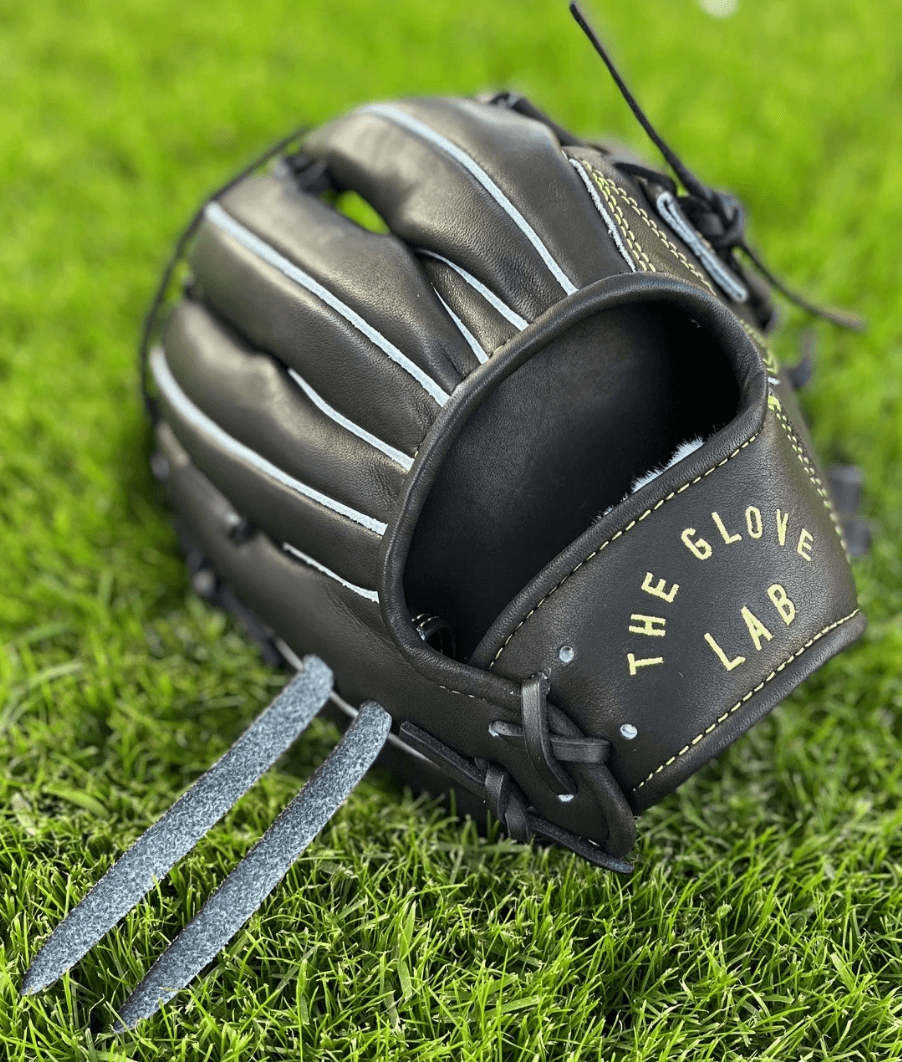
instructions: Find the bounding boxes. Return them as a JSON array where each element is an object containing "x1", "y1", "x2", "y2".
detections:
[{"x1": 24, "y1": 0, "x2": 865, "y2": 1025}]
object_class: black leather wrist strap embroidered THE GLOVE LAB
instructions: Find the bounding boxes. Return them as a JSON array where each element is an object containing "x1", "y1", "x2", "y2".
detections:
[{"x1": 474, "y1": 401, "x2": 860, "y2": 806}]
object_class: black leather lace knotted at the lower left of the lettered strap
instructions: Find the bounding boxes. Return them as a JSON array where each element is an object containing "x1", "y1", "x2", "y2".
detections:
[{"x1": 401, "y1": 673, "x2": 635, "y2": 874}]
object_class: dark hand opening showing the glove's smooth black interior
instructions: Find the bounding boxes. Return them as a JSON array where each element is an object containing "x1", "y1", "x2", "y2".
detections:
[{"x1": 405, "y1": 306, "x2": 738, "y2": 658}]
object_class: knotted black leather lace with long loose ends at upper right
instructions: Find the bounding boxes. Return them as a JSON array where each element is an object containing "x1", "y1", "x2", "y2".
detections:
[{"x1": 569, "y1": 2, "x2": 866, "y2": 331}]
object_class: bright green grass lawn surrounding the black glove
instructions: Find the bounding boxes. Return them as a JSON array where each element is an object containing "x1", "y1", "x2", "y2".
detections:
[{"x1": 0, "y1": 0, "x2": 902, "y2": 1062}]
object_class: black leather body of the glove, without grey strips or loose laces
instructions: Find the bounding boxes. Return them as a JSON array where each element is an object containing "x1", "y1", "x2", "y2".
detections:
[{"x1": 149, "y1": 89, "x2": 864, "y2": 855}]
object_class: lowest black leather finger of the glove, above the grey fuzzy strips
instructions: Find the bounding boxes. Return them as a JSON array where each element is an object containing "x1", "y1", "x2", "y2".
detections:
[{"x1": 157, "y1": 424, "x2": 626, "y2": 855}]
